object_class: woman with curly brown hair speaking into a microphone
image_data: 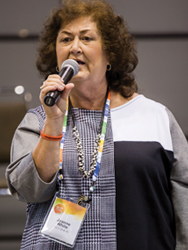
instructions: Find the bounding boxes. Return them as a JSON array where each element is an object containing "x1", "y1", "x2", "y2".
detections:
[{"x1": 6, "y1": 0, "x2": 188, "y2": 250}]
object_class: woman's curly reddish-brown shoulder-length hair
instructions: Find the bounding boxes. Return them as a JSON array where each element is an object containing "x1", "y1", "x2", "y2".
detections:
[{"x1": 37, "y1": 0, "x2": 138, "y2": 97}]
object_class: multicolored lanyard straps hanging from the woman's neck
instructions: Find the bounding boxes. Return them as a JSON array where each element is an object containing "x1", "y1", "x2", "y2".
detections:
[{"x1": 59, "y1": 90, "x2": 110, "y2": 195}]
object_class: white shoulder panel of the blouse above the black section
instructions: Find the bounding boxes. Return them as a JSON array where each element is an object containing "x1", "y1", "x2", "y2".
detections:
[{"x1": 111, "y1": 95, "x2": 172, "y2": 151}]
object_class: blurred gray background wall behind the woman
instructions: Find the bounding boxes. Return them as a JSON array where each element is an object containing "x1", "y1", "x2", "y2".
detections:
[{"x1": 0, "y1": 0, "x2": 188, "y2": 250}]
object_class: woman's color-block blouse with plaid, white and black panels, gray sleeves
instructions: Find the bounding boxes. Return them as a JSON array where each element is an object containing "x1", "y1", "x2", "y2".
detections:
[{"x1": 6, "y1": 95, "x2": 188, "y2": 250}]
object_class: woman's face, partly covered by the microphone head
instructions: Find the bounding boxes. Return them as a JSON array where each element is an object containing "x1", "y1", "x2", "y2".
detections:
[{"x1": 56, "y1": 17, "x2": 108, "y2": 89}]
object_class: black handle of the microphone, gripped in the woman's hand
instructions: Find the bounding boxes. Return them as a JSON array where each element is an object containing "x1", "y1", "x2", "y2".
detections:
[{"x1": 44, "y1": 67, "x2": 74, "y2": 107}]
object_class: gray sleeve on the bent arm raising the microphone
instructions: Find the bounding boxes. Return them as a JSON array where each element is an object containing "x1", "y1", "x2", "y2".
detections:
[{"x1": 6, "y1": 113, "x2": 57, "y2": 203}]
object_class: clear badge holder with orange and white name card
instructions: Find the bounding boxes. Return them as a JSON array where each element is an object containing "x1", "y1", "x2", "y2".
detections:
[{"x1": 40, "y1": 194, "x2": 89, "y2": 248}]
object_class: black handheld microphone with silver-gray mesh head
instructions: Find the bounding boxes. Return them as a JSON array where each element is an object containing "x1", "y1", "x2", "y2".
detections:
[{"x1": 44, "y1": 59, "x2": 79, "y2": 107}]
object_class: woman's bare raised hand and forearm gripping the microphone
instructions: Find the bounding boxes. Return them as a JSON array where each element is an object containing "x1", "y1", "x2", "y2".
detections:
[{"x1": 32, "y1": 75, "x2": 74, "y2": 182}]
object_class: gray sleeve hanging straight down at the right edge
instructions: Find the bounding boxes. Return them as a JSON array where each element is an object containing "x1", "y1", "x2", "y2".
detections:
[{"x1": 167, "y1": 110, "x2": 188, "y2": 250}]
